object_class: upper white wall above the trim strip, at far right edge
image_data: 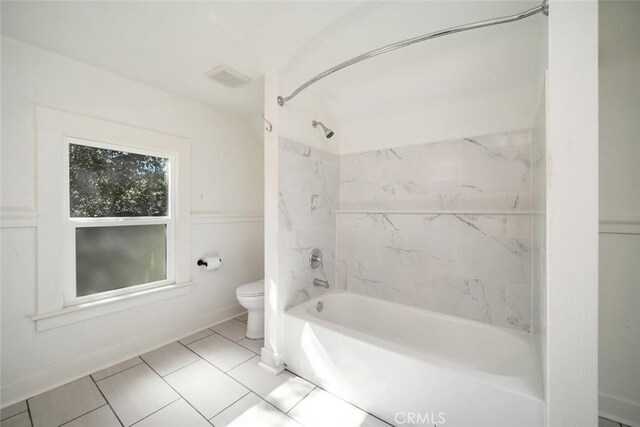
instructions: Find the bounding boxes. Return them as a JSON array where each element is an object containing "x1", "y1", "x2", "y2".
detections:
[{"x1": 599, "y1": 1, "x2": 640, "y2": 218}]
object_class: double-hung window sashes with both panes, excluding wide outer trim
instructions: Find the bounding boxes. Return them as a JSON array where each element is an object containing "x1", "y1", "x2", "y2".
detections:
[{"x1": 65, "y1": 137, "x2": 174, "y2": 304}]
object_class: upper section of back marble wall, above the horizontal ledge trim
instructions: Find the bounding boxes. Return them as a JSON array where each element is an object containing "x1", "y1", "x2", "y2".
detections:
[{"x1": 340, "y1": 131, "x2": 531, "y2": 211}]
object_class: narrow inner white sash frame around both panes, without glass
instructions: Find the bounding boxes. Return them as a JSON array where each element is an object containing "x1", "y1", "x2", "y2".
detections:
[{"x1": 63, "y1": 136, "x2": 177, "y2": 306}]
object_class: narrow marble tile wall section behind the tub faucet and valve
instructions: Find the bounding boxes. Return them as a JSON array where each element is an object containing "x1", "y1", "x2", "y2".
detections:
[{"x1": 278, "y1": 138, "x2": 340, "y2": 307}]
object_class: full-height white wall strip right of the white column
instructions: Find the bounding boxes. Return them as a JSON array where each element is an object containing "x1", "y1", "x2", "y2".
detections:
[{"x1": 598, "y1": 1, "x2": 640, "y2": 426}]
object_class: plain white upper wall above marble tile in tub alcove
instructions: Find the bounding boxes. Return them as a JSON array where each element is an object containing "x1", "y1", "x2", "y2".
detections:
[{"x1": 279, "y1": 0, "x2": 547, "y2": 154}]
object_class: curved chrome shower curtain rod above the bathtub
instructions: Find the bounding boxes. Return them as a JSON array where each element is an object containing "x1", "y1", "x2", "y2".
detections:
[{"x1": 278, "y1": 0, "x2": 549, "y2": 106}]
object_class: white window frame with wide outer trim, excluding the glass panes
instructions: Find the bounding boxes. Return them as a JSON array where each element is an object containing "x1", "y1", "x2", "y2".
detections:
[{"x1": 31, "y1": 107, "x2": 192, "y2": 331}]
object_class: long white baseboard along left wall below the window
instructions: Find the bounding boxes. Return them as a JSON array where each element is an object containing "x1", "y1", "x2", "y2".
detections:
[{"x1": 0, "y1": 304, "x2": 246, "y2": 408}]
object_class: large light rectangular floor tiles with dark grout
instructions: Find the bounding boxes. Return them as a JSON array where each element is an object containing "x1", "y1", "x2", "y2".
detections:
[{"x1": 0, "y1": 315, "x2": 390, "y2": 427}]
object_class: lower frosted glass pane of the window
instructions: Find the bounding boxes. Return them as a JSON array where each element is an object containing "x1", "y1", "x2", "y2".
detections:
[{"x1": 76, "y1": 224, "x2": 167, "y2": 297}]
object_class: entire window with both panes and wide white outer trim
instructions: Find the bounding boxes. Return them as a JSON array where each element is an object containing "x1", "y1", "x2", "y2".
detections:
[{"x1": 32, "y1": 107, "x2": 191, "y2": 331}]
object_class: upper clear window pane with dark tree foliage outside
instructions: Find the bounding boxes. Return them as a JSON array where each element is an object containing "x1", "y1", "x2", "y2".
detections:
[{"x1": 69, "y1": 144, "x2": 169, "y2": 218}]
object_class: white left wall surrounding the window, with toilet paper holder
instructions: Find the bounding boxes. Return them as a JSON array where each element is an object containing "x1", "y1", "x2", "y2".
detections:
[{"x1": 1, "y1": 37, "x2": 263, "y2": 406}]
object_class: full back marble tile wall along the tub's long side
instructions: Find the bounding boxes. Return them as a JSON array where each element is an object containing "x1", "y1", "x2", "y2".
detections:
[{"x1": 337, "y1": 131, "x2": 532, "y2": 331}]
